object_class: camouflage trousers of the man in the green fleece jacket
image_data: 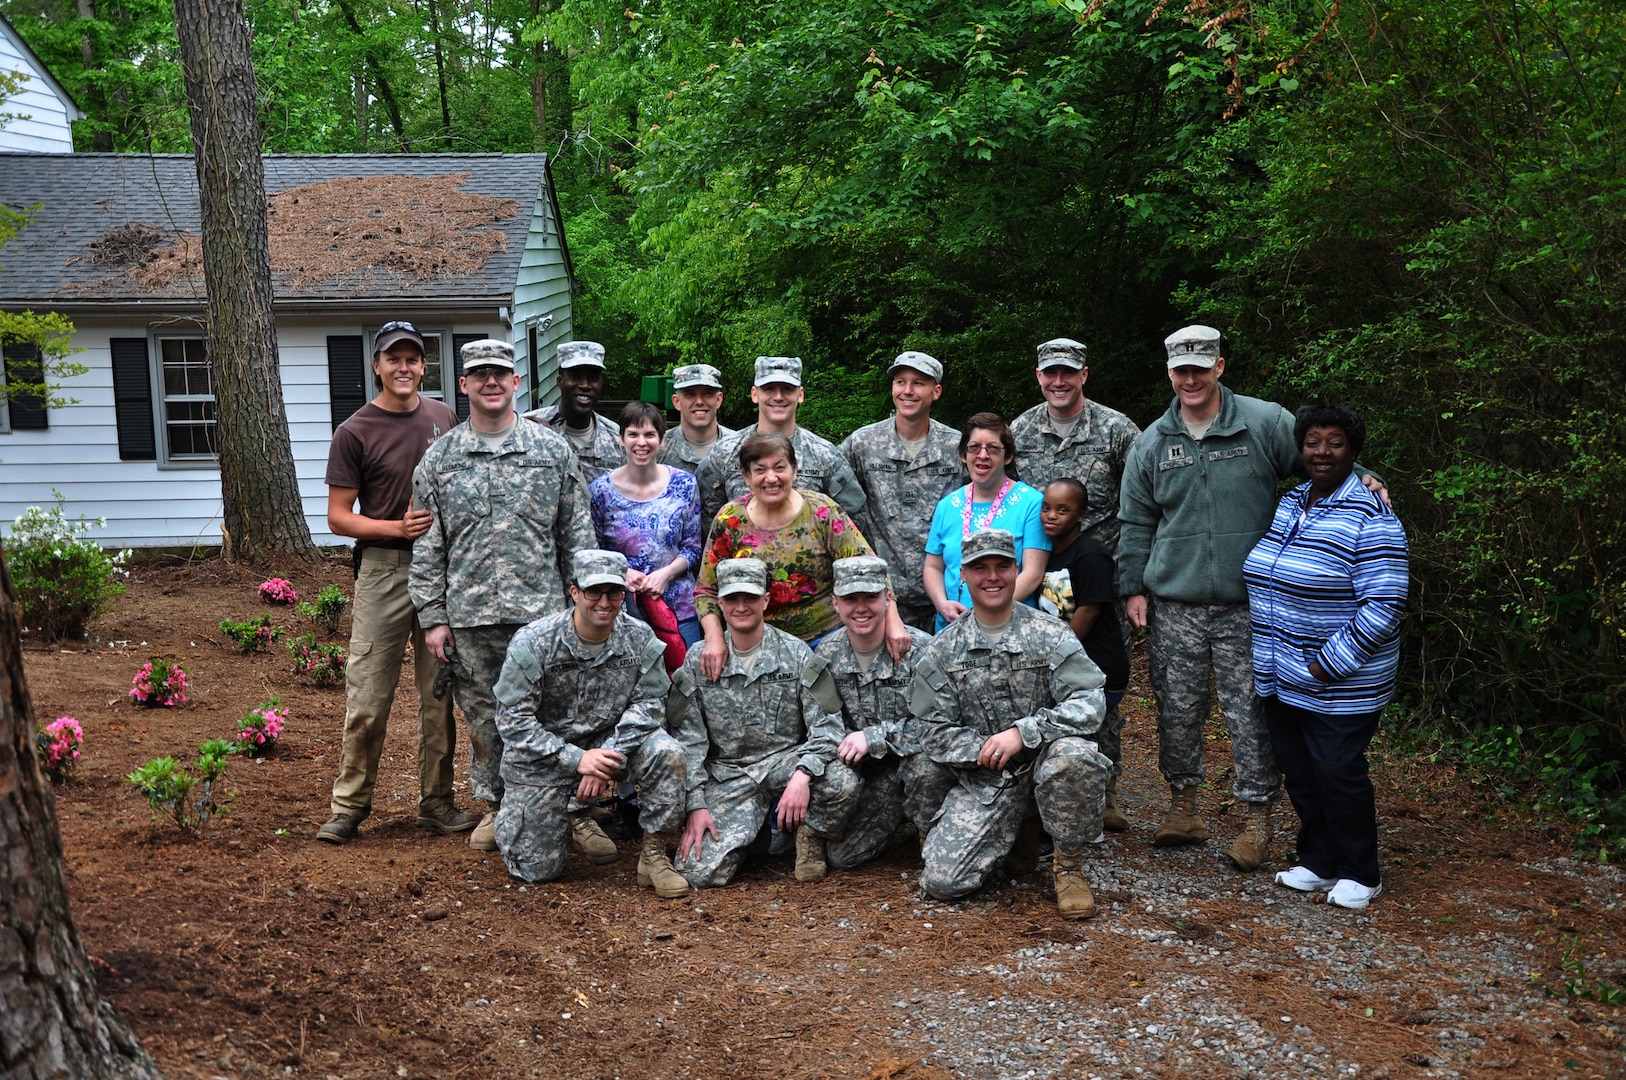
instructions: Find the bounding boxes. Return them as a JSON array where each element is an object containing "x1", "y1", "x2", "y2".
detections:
[{"x1": 1150, "y1": 600, "x2": 1281, "y2": 802}]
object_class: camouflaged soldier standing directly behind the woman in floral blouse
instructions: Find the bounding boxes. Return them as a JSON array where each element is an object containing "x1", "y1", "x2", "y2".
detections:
[{"x1": 694, "y1": 356, "x2": 863, "y2": 535}]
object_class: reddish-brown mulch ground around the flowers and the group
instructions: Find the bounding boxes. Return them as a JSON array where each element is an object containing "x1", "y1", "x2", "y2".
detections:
[{"x1": 15, "y1": 561, "x2": 1626, "y2": 1080}]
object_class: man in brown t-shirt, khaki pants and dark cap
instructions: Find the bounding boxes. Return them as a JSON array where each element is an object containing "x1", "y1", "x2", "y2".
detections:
[{"x1": 315, "y1": 322, "x2": 480, "y2": 844}]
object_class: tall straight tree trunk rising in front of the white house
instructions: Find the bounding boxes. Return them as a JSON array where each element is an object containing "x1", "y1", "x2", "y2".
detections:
[{"x1": 176, "y1": 0, "x2": 315, "y2": 561}]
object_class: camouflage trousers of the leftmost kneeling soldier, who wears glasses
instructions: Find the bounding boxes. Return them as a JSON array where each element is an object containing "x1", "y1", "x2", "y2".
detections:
[{"x1": 496, "y1": 732, "x2": 688, "y2": 882}]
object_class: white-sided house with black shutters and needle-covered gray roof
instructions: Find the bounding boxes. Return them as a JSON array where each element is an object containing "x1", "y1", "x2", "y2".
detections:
[{"x1": 0, "y1": 153, "x2": 572, "y2": 547}]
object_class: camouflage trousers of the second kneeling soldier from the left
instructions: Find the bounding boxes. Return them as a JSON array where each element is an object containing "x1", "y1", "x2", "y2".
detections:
[{"x1": 675, "y1": 750, "x2": 859, "y2": 888}]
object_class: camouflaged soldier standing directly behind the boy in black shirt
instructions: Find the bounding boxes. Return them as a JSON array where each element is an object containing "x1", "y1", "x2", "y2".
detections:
[{"x1": 1011, "y1": 338, "x2": 1140, "y2": 831}]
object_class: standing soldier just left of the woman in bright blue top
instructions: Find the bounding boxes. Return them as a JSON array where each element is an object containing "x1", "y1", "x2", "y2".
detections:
[{"x1": 841, "y1": 353, "x2": 971, "y2": 633}]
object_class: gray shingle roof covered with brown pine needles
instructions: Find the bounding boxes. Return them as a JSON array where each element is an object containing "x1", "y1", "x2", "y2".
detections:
[{"x1": 0, "y1": 155, "x2": 559, "y2": 307}]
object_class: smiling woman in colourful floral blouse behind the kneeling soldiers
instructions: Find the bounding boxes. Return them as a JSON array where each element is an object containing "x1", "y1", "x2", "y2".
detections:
[{"x1": 694, "y1": 431, "x2": 909, "y2": 680}]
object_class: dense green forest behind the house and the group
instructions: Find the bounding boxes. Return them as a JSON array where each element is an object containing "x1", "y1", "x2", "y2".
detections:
[{"x1": 0, "y1": 0, "x2": 1626, "y2": 857}]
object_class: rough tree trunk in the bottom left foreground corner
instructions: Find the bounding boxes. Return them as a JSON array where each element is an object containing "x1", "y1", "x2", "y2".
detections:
[{"x1": 0, "y1": 551, "x2": 158, "y2": 1080}]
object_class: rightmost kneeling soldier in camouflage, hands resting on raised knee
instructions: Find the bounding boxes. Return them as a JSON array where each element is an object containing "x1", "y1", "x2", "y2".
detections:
[{"x1": 909, "y1": 529, "x2": 1112, "y2": 919}]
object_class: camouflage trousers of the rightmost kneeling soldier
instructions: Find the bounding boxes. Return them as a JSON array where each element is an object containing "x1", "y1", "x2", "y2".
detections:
[{"x1": 920, "y1": 735, "x2": 1112, "y2": 899}]
